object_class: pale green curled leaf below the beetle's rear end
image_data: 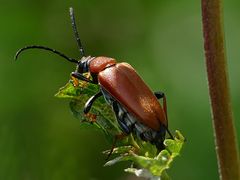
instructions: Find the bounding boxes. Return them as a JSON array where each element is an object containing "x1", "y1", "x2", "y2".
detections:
[{"x1": 105, "y1": 131, "x2": 185, "y2": 178}]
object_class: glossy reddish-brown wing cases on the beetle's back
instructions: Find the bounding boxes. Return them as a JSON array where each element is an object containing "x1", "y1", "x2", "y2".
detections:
[{"x1": 98, "y1": 63, "x2": 167, "y2": 131}]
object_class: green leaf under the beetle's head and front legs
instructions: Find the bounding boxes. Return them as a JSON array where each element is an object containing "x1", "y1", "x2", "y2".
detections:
[{"x1": 55, "y1": 80, "x2": 121, "y2": 142}]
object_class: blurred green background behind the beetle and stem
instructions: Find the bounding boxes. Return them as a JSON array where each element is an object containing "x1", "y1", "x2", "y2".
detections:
[{"x1": 0, "y1": 0, "x2": 240, "y2": 180}]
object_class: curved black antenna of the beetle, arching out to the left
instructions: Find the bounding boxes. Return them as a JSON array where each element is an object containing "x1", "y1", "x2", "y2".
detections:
[{"x1": 15, "y1": 45, "x2": 78, "y2": 63}]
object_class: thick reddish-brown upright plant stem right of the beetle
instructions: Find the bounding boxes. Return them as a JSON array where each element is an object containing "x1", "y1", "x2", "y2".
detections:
[{"x1": 202, "y1": 0, "x2": 240, "y2": 180}]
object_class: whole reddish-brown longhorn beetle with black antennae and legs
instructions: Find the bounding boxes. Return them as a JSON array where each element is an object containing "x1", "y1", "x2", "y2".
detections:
[{"x1": 16, "y1": 8, "x2": 172, "y2": 150}]
